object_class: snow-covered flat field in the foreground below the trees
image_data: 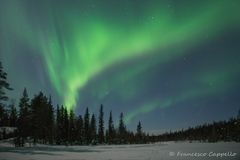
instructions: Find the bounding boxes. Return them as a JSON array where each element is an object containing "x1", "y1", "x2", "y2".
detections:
[{"x1": 0, "y1": 142, "x2": 240, "y2": 160}]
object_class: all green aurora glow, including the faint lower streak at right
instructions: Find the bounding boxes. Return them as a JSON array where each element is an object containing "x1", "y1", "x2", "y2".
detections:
[{"x1": 0, "y1": 0, "x2": 240, "y2": 120}]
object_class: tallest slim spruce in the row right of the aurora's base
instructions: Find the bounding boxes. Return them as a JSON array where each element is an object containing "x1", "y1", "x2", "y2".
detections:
[{"x1": 98, "y1": 104, "x2": 104, "y2": 144}]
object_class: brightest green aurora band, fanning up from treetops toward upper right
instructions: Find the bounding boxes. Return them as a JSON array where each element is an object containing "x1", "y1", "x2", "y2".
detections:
[{"x1": 42, "y1": 0, "x2": 240, "y2": 108}]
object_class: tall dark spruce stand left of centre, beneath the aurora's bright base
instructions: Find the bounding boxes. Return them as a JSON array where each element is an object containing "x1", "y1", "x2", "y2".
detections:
[{"x1": 3, "y1": 89, "x2": 144, "y2": 146}]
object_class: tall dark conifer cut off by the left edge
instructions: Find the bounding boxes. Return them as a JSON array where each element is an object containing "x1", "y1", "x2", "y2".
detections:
[{"x1": 0, "y1": 62, "x2": 12, "y2": 126}]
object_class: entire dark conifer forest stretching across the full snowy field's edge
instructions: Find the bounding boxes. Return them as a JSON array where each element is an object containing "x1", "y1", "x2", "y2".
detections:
[{"x1": 0, "y1": 62, "x2": 240, "y2": 147}]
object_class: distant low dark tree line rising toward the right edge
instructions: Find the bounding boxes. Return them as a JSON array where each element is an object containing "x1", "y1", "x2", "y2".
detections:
[{"x1": 150, "y1": 116, "x2": 240, "y2": 142}]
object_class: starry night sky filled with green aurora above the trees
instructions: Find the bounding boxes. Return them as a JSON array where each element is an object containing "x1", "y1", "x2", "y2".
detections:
[{"x1": 0, "y1": 0, "x2": 240, "y2": 132}]
